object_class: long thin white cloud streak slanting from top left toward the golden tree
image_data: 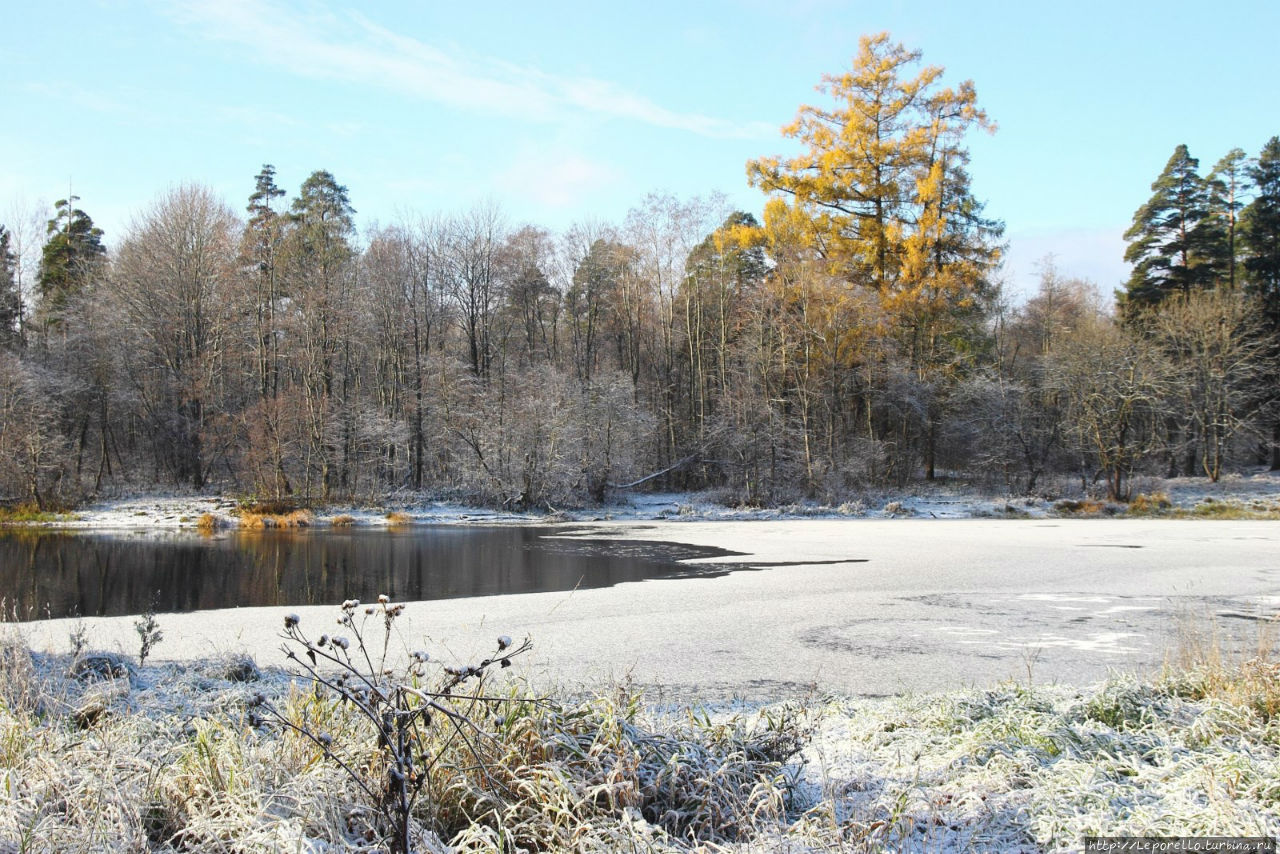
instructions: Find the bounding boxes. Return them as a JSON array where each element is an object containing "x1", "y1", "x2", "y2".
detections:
[{"x1": 162, "y1": 0, "x2": 777, "y2": 138}]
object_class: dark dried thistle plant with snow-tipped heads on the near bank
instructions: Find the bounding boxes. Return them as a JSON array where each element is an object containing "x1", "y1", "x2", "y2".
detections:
[{"x1": 250, "y1": 595, "x2": 532, "y2": 854}]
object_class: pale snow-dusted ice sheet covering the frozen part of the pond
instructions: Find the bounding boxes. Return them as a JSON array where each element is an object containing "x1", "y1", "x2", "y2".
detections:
[{"x1": 12, "y1": 520, "x2": 1280, "y2": 699}]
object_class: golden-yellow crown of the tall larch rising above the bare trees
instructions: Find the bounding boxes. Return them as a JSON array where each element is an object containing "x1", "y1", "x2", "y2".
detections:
[{"x1": 735, "y1": 33, "x2": 1000, "y2": 367}]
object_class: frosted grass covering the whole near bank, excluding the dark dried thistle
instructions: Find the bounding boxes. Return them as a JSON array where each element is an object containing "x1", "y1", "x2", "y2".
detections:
[{"x1": 0, "y1": 617, "x2": 1280, "y2": 853}]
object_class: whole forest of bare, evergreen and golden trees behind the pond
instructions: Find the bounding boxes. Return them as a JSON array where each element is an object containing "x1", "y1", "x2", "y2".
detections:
[{"x1": 0, "y1": 35, "x2": 1280, "y2": 510}]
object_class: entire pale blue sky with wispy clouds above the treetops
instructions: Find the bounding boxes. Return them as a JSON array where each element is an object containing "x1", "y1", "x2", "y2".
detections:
[{"x1": 0, "y1": 0, "x2": 1280, "y2": 294}]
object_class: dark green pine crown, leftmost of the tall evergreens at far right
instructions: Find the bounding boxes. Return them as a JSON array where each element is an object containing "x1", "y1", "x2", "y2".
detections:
[{"x1": 1120, "y1": 145, "x2": 1215, "y2": 311}]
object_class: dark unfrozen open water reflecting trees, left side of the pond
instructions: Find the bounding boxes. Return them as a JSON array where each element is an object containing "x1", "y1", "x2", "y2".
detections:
[{"x1": 0, "y1": 525, "x2": 740, "y2": 617}]
